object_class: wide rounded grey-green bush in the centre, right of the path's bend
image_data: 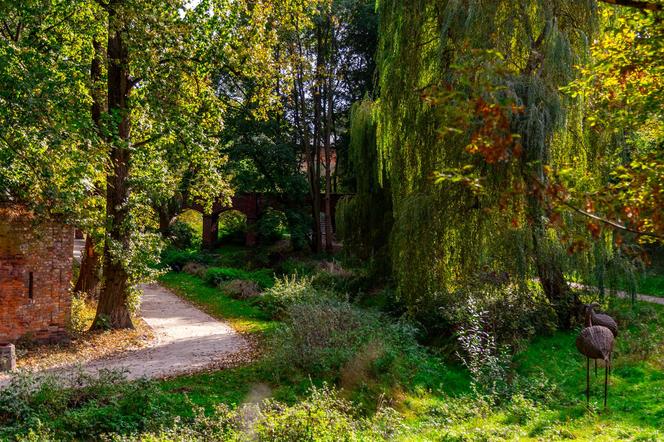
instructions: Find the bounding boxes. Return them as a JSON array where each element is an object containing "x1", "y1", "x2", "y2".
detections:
[{"x1": 271, "y1": 299, "x2": 423, "y2": 383}]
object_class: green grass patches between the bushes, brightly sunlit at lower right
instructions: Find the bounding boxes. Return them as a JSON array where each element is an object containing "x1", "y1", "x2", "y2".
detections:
[{"x1": 6, "y1": 258, "x2": 664, "y2": 441}]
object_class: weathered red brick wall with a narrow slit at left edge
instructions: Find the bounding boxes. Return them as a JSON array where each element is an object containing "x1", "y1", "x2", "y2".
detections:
[{"x1": 0, "y1": 206, "x2": 74, "y2": 344}]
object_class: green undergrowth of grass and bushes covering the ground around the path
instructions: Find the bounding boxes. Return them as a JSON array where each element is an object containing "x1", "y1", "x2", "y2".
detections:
[{"x1": 0, "y1": 248, "x2": 664, "y2": 441}]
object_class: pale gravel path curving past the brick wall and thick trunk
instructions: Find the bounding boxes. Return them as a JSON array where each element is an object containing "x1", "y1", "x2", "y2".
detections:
[{"x1": 0, "y1": 284, "x2": 249, "y2": 386}]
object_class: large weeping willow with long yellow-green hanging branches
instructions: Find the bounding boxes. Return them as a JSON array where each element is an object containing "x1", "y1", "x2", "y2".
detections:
[{"x1": 378, "y1": 0, "x2": 597, "y2": 327}]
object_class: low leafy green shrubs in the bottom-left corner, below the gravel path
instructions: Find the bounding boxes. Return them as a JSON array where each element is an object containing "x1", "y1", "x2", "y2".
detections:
[{"x1": 0, "y1": 371, "x2": 174, "y2": 440}]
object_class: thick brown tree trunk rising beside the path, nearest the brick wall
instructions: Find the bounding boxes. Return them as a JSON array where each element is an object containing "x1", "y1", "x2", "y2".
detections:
[{"x1": 93, "y1": 2, "x2": 134, "y2": 328}]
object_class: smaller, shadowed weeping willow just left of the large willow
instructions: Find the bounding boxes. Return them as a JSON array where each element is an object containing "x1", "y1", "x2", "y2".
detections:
[{"x1": 336, "y1": 99, "x2": 392, "y2": 264}]
